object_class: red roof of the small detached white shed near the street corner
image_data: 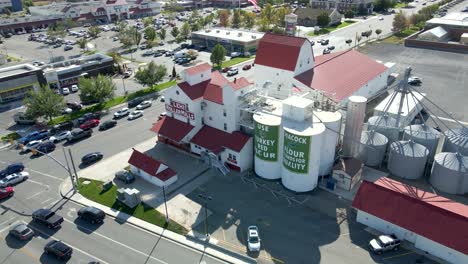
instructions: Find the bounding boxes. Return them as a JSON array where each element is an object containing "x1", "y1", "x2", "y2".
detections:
[{"x1": 128, "y1": 149, "x2": 176, "y2": 181}]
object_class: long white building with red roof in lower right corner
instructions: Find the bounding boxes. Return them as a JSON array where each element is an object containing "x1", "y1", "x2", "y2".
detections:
[{"x1": 353, "y1": 178, "x2": 468, "y2": 264}]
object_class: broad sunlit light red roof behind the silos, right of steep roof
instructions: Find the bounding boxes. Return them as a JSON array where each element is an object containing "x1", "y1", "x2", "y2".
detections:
[{"x1": 295, "y1": 50, "x2": 387, "y2": 102}]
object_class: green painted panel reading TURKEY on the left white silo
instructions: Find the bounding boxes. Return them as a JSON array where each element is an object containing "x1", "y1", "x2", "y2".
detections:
[{"x1": 255, "y1": 122, "x2": 279, "y2": 161}]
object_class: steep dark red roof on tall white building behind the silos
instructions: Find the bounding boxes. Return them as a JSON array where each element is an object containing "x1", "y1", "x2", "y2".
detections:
[{"x1": 255, "y1": 33, "x2": 307, "y2": 71}]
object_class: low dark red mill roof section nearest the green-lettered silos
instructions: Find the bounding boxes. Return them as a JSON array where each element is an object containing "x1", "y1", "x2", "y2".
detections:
[{"x1": 190, "y1": 126, "x2": 250, "y2": 153}]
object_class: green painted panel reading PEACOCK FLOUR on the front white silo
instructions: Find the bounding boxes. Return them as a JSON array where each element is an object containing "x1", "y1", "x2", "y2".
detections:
[{"x1": 283, "y1": 130, "x2": 311, "y2": 174}]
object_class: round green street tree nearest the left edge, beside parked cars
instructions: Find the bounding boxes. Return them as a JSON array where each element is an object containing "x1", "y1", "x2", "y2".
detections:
[{"x1": 24, "y1": 86, "x2": 65, "y2": 121}]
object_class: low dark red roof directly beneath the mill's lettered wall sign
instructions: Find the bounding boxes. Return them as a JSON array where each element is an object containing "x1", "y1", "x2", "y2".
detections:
[{"x1": 151, "y1": 116, "x2": 194, "y2": 142}]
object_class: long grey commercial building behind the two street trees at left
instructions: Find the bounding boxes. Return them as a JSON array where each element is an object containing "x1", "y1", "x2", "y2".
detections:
[{"x1": 43, "y1": 53, "x2": 114, "y2": 89}]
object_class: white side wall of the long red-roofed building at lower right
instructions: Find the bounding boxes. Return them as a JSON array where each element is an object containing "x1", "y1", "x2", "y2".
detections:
[{"x1": 356, "y1": 210, "x2": 468, "y2": 264}]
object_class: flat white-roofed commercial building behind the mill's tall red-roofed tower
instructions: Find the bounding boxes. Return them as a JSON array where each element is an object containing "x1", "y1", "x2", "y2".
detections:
[{"x1": 192, "y1": 28, "x2": 264, "y2": 55}]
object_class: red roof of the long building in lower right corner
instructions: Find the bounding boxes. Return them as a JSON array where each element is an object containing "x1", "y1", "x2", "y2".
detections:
[{"x1": 353, "y1": 178, "x2": 468, "y2": 254}]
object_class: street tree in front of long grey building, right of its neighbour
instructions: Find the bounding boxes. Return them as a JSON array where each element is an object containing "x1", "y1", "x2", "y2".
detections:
[{"x1": 79, "y1": 75, "x2": 116, "y2": 104}]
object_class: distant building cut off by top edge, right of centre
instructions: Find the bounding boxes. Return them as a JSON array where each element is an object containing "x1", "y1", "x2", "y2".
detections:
[{"x1": 310, "y1": 0, "x2": 374, "y2": 14}]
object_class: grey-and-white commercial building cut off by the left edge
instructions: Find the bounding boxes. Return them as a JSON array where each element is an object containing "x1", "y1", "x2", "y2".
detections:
[{"x1": 0, "y1": 64, "x2": 46, "y2": 103}]
